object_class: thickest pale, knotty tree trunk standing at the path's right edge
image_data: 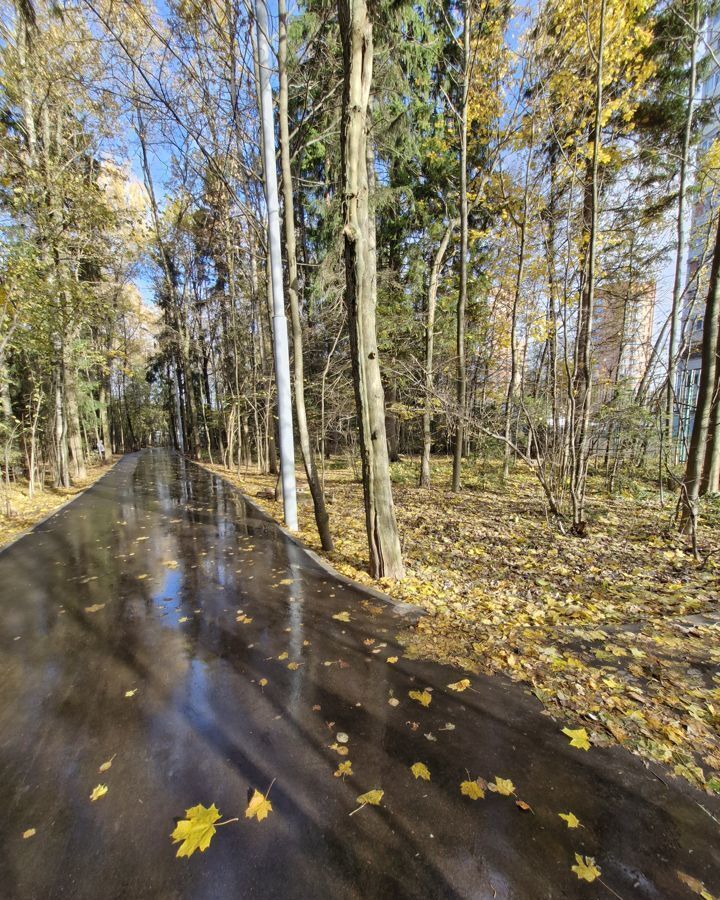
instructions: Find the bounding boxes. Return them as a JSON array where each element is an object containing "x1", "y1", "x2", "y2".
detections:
[{"x1": 338, "y1": 0, "x2": 405, "y2": 578}]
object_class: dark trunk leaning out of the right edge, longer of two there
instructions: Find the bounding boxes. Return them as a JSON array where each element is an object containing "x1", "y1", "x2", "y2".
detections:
[{"x1": 680, "y1": 216, "x2": 720, "y2": 534}]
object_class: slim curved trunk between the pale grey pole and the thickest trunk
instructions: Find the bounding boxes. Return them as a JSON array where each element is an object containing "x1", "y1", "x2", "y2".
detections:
[{"x1": 278, "y1": 0, "x2": 333, "y2": 550}]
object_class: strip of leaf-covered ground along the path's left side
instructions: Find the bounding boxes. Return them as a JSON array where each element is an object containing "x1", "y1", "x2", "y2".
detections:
[{"x1": 0, "y1": 457, "x2": 118, "y2": 550}]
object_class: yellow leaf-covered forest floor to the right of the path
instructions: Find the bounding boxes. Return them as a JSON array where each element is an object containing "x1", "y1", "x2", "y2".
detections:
[{"x1": 202, "y1": 459, "x2": 720, "y2": 793}]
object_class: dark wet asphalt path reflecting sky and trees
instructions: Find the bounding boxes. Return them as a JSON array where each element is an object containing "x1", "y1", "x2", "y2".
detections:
[{"x1": 0, "y1": 451, "x2": 720, "y2": 900}]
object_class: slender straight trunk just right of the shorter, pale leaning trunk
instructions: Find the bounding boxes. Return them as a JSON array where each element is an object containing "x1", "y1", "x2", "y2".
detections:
[{"x1": 452, "y1": 0, "x2": 470, "y2": 492}]
